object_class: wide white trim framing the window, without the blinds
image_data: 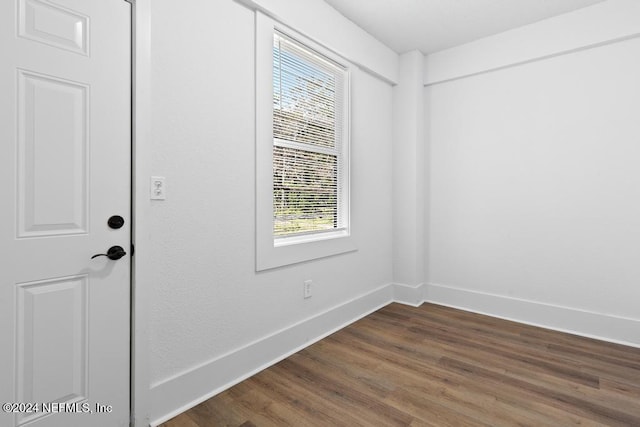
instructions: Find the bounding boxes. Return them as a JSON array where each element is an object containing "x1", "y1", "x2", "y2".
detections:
[{"x1": 256, "y1": 11, "x2": 356, "y2": 271}]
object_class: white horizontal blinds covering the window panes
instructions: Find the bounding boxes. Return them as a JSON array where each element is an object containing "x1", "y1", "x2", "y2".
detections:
[{"x1": 273, "y1": 32, "x2": 348, "y2": 238}]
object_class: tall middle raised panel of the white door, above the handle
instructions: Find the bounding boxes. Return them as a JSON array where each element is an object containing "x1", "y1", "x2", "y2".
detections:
[{"x1": 17, "y1": 70, "x2": 89, "y2": 238}]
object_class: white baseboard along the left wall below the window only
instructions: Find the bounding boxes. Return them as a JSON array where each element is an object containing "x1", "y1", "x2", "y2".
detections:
[{"x1": 150, "y1": 285, "x2": 394, "y2": 426}]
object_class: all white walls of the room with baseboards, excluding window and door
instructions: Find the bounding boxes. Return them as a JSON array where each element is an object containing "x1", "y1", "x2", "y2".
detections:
[{"x1": 134, "y1": 0, "x2": 640, "y2": 425}]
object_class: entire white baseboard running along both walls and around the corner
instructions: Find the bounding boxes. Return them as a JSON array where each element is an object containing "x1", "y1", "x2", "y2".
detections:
[{"x1": 150, "y1": 283, "x2": 640, "y2": 426}]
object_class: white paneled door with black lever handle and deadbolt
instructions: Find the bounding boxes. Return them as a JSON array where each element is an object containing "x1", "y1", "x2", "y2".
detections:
[{"x1": 0, "y1": 0, "x2": 131, "y2": 427}]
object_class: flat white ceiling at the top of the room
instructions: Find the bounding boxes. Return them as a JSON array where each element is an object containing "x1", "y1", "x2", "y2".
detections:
[{"x1": 325, "y1": 0, "x2": 603, "y2": 54}]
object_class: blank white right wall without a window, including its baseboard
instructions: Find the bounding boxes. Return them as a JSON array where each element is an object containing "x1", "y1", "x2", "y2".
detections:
[{"x1": 425, "y1": 12, "x2": 640, "y2": 345}]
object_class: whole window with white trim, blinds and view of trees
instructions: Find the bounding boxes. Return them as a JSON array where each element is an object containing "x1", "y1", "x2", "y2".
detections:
[{"x1": 256, "y1": 12, "x2": 355, "y2": 270}]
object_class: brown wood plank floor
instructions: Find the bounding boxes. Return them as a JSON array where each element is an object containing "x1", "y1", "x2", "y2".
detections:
[{"x1": 163, "y1": 304, "x2": 640, "y2": 427}]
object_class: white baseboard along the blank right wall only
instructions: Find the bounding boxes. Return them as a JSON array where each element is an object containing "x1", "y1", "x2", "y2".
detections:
[{"x1": 424, "y1": 283, "x2": 640, "y2": 347}]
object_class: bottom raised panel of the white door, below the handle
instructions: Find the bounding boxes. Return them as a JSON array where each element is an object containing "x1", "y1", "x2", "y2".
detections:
[{"x1": 15, "y1": 275, "x2": 89, "y2": 425}]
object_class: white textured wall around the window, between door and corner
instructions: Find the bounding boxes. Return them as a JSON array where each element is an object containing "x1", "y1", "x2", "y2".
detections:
[{"x1": 145, "y1": 0, "x2": 395, "y2": 421}]
